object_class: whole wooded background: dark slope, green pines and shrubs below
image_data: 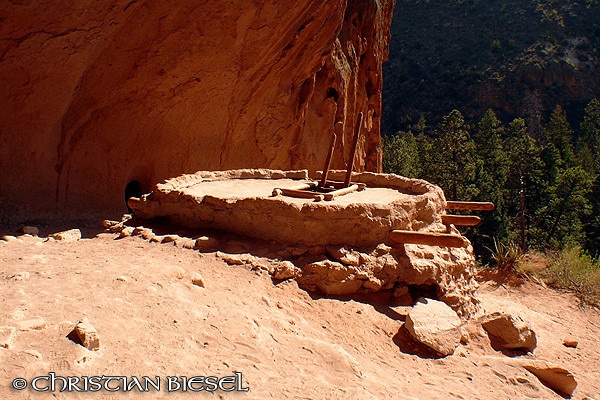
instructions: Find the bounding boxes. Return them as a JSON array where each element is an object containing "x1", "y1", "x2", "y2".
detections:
[{"x1": 382, "y1": 0, "x2": 600, "y2": 303}]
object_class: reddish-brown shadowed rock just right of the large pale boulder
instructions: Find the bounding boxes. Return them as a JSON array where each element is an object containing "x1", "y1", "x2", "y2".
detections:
[{"x1": 481, "y1": 313, "x2": 537, "y2": 352}]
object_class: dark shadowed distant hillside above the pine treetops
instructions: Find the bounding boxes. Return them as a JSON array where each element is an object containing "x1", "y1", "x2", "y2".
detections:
[{"x1": 382, "y1": 0, "x2": 600, "y2": 136}]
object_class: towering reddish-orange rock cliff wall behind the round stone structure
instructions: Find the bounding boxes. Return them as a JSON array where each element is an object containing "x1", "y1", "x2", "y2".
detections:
[{"x1": 0, "y1": 0, "x2": 394, "y2": 221}]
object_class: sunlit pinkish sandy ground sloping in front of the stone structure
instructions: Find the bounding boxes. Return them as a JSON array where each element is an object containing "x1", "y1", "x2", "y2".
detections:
[{"x1": 0, "y1": 225, "x2": 600, "y2": 399}]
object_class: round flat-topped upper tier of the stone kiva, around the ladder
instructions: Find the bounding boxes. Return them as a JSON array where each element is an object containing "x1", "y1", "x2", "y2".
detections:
[{"x1": 130, "y1": 169, "x2": 445, "y2": 246}]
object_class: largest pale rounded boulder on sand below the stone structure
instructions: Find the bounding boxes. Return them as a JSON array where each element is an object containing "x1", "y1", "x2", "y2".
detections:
[{"x1": 404, "y1": 297, "x2": 462, "y2": 356}]
